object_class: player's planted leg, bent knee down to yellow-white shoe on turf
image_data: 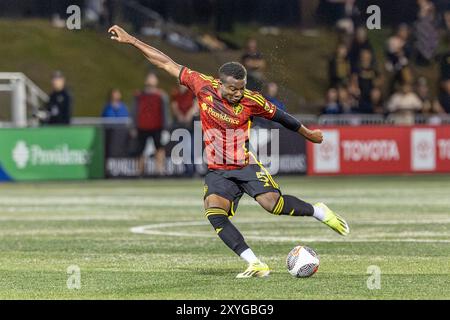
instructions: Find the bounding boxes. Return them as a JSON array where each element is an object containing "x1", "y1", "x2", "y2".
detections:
[{"x1": 205, "y1": 194, "x2": 270, "y2": 278}]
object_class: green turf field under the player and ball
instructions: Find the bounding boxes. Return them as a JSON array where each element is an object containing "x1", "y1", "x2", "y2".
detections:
[{"x1": 0, "y1": 175, "x2": 450, "y2": 299}]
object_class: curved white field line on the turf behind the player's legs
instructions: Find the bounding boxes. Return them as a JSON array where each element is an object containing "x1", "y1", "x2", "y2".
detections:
[{"x1": 130, "y1": 220, "x2": 450, "y2": 243}]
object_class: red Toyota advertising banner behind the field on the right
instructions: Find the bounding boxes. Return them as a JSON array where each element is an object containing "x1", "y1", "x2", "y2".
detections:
[{"x1": 307, "y1": 126, "x2": 450, "y2": 175}]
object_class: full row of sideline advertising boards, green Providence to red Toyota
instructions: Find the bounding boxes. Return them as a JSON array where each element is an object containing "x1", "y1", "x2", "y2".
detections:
[{"x1": 0, "y1": 125, "x2": 450, "y2": 181}]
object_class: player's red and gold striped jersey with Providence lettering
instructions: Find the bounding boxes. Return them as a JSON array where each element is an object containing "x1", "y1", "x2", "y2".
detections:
[{"x1": 179, "y1": 67, "x2": 276, "y2": 170}]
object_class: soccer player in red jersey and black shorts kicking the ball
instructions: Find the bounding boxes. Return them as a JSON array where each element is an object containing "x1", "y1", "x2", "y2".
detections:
[{"x1": 109, "y1": 26, "x2": 350, "y2": 278}]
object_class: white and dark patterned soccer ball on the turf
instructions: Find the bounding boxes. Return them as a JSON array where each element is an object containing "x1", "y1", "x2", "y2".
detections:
[{"x1": 286, "y1": 246, "x2": 319, "y2": 278}]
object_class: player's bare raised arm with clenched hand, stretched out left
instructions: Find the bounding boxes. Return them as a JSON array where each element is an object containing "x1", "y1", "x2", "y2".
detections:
[{"x1": 108, "y1": 25, "x2": 182, "y2": 78}]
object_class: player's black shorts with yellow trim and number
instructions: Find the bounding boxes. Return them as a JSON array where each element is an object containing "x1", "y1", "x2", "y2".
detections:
[{"x1": 203, "y1": 164, "x2": 281, "y2": 216}]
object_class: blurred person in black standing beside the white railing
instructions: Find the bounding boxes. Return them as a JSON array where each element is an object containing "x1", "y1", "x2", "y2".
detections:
[{"x1": 44, "y1": 71, "x2": 72, "y2": 124}]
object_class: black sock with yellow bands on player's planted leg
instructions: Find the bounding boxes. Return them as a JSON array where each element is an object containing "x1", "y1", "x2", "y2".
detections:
[{"x1": 206, "y1": 208, "x2": 249, "y2": 256}]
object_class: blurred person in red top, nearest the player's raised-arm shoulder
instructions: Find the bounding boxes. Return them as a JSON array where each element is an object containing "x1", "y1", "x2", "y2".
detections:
[{"x1": 171, "y1": 85, "x2": 196, "y2": 129}]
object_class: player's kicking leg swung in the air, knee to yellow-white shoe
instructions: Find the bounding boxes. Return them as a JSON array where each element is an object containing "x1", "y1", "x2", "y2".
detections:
[{"x1": 256, "y1": 192, "x2": 350, "y2": 236}]
